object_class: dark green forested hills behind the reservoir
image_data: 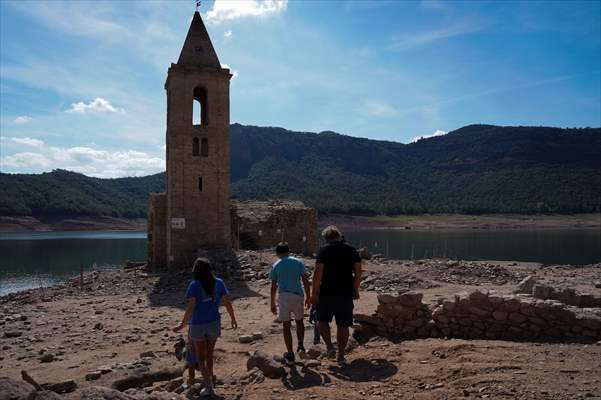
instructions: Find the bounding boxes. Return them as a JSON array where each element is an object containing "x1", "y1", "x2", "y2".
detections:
[{"x1": 0, "y1": 124, "x2": 601, "y2": 217}]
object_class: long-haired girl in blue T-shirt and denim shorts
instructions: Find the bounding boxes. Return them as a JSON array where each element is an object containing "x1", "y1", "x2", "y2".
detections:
[{"x1": 173, "y1": 258, "x2": 238, "y2": 395}]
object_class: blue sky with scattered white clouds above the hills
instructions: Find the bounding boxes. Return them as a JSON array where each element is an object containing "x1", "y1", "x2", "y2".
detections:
[{"x1": 0, "y1": 0, "x2": 601, "y2": 177}]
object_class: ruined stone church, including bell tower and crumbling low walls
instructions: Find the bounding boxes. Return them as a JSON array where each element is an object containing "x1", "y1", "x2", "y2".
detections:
[{"x1": 148, "y1": 11, "x2": 317, "y2": 268}]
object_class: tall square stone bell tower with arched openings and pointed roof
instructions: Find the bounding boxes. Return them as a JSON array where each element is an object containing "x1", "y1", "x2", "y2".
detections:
[{"x1": 164, "y1": 11, "x2": 232, "y2": 268}]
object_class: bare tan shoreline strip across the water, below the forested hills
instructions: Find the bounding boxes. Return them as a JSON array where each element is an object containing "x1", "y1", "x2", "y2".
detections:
[{"x1": 0, "y1": 214, "x2": 601, "y2": 233}]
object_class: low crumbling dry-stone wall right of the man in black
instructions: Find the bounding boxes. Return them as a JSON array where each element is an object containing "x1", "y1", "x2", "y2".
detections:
[{"x1": 355, "y1": 291, "x2": 601, "y2": 342}]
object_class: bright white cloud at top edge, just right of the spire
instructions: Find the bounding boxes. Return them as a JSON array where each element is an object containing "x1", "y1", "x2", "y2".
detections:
[{"x1": 207, "y1": 0, "x2": 288, "y2": 23}]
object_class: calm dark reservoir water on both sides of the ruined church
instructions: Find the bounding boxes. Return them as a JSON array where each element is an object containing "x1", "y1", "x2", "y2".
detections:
[{"x1": 0, "y1": 229, "x2": 601, "y2": 295}]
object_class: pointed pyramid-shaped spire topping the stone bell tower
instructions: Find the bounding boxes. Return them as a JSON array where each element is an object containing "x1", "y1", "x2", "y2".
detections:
[{"x1": 177, "y1": 11, "x2": 221, "y2": 69}]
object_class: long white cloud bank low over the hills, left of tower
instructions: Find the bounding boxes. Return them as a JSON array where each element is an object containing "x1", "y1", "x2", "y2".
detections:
[{"x1": 0, "y1": 138, "x2": 165, "y2": 178}]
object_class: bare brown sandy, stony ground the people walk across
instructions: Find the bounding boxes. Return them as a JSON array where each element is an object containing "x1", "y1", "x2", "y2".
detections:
[{"x1": 0, "y1": 252, "x2": 601, "y2": 400}]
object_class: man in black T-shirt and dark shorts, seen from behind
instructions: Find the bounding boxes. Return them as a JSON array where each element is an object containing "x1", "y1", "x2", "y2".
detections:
[{"x1": 311, "y1": 225, "x2": 361, "y2": 365}]
